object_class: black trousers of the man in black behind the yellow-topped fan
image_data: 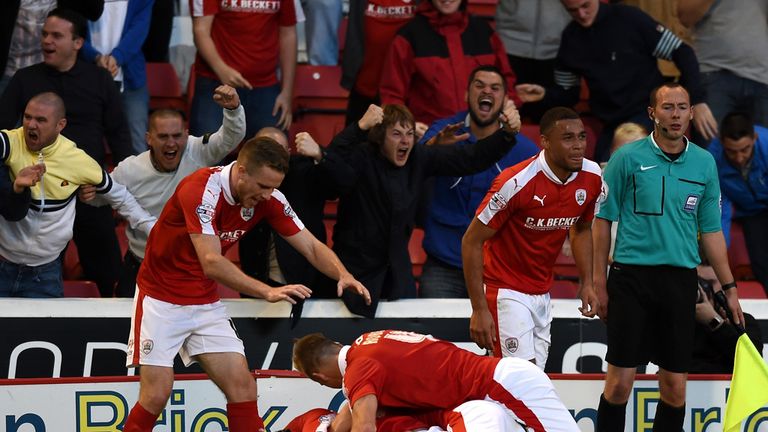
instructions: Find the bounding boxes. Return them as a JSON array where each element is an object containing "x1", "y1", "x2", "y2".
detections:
[{"x1": 73, "y1": 201, "x2": 120, "y2": 297}]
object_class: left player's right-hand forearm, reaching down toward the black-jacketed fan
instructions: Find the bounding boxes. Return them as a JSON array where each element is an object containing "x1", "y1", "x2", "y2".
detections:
[{"x1": 285, "y1": 228, "x2": 371, "y2": 304}]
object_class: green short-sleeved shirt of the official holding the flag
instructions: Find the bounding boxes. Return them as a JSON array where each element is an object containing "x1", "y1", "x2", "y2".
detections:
[{"x1": 597, "y1": 135, "x2": 721, "y2": 268}]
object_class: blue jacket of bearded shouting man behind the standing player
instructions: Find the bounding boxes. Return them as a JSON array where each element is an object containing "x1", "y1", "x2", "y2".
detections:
[{"x1": 420, "y1": 111, "x2": 539, "y2": 268}]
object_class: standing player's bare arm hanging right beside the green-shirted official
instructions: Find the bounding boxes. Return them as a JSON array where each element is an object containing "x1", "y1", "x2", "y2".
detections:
[{"x1": 570, "y1": 220, "x2": 600, "y2": 318}]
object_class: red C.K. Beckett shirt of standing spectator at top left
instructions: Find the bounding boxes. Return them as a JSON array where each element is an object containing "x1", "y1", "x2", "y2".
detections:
[{"x1": 189, "y1": 0, "x2": 296, "y2": 87}]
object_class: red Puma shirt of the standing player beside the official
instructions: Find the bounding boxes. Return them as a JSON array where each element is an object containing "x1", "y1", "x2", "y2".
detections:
[{"x1": 477, "y1": 151, "x2": 602, "y2": 294}]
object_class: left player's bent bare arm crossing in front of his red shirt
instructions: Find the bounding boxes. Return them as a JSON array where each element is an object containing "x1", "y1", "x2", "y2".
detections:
[{"x1": 189, "y1": 234, "x2": 312, "y2": 304}]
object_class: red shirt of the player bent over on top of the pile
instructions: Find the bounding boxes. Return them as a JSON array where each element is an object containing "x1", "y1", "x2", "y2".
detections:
[{"x1": 339, "y1": 330, "x2": 500, "y2": 409}]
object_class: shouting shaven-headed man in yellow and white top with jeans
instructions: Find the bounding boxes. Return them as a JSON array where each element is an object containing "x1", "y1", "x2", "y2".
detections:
[{"x1": 0, "y1": 92, "x2": 155, "y2": 297}]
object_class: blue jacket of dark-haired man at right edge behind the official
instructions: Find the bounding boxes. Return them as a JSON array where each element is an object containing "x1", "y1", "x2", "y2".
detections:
[{"x1": 709, "y1": 126, "x2": 768, "y2": 218}]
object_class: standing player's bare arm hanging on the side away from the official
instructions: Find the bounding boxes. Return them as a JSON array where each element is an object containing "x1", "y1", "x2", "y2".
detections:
[{"x1": 461, "y1": 218, "x2": 496, "y2": 351}]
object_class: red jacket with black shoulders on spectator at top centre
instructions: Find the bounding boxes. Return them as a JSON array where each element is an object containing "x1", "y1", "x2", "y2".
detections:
[{"x1": 379, "y1": 0, "x2": 515, "y2": 124}]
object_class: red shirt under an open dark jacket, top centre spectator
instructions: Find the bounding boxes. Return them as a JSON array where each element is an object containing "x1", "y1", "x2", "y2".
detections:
[{"x1": 355, "y1": 0, "x2": 416, "y2": 98}]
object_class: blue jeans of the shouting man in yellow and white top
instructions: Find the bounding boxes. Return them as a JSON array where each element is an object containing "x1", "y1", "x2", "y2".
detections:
[{"x1": 0, "y1": 258, "x2": 64, "y2": 298}]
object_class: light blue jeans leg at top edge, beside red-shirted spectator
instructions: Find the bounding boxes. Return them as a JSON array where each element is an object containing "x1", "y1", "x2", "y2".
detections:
[{"x1": 301, "y1": 0, "x2": 341, "y2": 66}]
